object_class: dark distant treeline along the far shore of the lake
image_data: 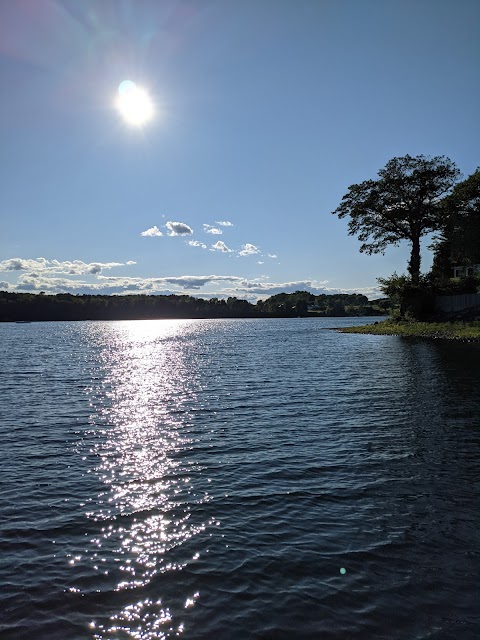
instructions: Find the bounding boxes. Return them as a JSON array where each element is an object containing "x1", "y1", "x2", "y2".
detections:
[{"x1": 0, "y1": 291, "x2": 388, "y2": 322}]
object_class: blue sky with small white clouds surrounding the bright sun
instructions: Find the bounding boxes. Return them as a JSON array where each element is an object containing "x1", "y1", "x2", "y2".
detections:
[{"x1": 0, "y1": 0, "x2": 480, "y2": 301}]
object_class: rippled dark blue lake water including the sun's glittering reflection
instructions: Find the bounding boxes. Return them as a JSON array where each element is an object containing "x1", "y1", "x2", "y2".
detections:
[{"x1": 0, "y1": 318, "x2": 480, "y2": 640}]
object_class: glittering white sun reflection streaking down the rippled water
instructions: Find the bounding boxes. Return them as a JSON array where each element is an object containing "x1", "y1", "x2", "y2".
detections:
[{"x1": 78, "y1": 320, "x2": 210, "y2": 640}]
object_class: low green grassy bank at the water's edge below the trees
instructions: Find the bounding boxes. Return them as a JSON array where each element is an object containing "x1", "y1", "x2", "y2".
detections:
[{"x1": 339, "y1": 320, "x2": 480, "y2": 342}]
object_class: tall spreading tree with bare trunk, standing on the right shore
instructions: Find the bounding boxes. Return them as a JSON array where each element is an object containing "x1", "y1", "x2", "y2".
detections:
[{"x1": 333, "y1": 155, "x2": 460, "y2": 283}]
